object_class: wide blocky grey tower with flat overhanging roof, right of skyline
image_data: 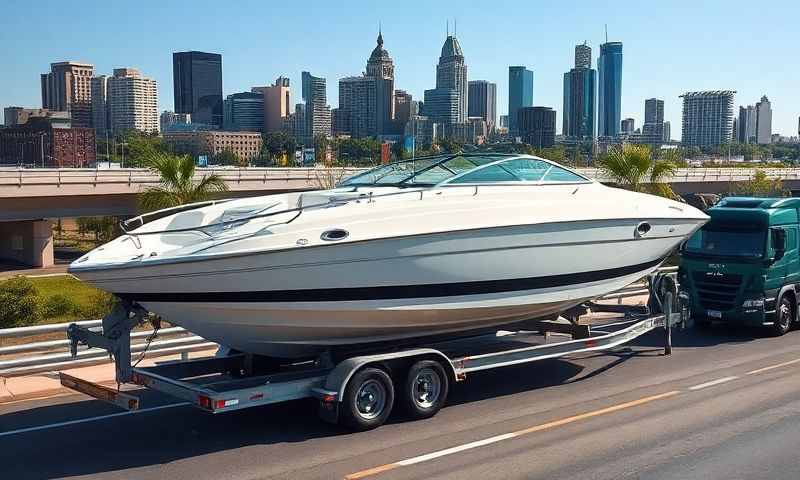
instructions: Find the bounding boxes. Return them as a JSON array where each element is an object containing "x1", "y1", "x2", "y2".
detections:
[{"x1": 681, "y1": 90, "x2": 736, "y2": 147}]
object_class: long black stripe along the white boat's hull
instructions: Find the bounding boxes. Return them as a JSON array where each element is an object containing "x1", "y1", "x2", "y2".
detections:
[{"x1": 117, "y1": 258, "x2": 664, "y2": 303}]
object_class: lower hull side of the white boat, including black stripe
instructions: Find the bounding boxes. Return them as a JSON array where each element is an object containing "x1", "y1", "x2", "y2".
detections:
[{"x1": 74, "y1": 219, "x2": 703, "y2": 357}]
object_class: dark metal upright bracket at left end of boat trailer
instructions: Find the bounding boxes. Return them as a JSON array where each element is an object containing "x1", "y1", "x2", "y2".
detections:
[{"x1": 67, "y1": 300, "x2": 148, "y2": 384}]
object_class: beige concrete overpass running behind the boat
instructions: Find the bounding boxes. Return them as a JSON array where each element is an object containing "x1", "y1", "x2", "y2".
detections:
[{"x1": 0, "y1": 168, "x2": 800, "y2": 266}]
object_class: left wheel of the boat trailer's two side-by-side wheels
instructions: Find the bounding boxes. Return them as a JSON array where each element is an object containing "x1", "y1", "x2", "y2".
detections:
[{"x1": 340, "y1": 368, "x2": 394, "y2": 432}]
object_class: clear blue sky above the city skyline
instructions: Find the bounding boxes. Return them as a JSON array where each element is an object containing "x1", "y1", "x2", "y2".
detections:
[{"x1": 0, "y1": 0, "x2": 800, "y2": 138}]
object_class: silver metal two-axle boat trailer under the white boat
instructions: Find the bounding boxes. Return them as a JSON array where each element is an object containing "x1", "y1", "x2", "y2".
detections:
[{"x1": 60, "y1": 273, "x2": 689, "y2": 430}]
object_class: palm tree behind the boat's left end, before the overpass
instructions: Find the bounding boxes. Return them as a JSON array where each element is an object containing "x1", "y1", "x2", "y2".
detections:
[{"x1": 139, "y1": 152, "x2": 228, "y2": 212}]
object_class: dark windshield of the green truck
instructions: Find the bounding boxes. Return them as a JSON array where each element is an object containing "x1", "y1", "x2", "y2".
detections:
[{"x1": 684, "y1": 228, "x2": 766, "y2": 258}]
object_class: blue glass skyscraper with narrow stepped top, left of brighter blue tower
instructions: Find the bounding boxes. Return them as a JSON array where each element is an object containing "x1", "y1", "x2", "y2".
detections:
[{"x1": 561, "y1": 43, "x2": 597, "y2": 140}]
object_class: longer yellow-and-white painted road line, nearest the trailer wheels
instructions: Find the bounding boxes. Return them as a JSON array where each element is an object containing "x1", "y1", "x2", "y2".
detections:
[{"x1": 344, "y1": 390, "x2": 681, "y2": 480}]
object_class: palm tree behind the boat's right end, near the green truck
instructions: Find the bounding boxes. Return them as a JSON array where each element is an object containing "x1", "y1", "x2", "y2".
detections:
[{"x1": 599, "y1": 144, "x2": 676, "y2": 198}]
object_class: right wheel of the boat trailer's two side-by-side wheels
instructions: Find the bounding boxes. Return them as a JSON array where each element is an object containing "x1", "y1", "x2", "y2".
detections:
[{"x1": 401, "y1": 360, "x2": 450, "y2": 420}]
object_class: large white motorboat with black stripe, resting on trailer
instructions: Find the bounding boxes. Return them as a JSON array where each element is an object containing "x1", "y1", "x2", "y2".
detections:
[{"x1": 70, "y1": 154, "x2": 708, "y2": 358}]
